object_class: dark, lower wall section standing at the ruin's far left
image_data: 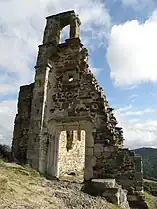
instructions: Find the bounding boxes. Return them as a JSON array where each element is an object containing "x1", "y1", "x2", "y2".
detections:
[{"x1": 12, "y1": 83, "x2": 34, "y2": 163}]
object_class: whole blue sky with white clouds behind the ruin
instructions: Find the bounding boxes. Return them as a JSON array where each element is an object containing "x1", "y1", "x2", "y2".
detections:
[{"x1": 0, "y1": 0, "x2": 157, "y2": 148}]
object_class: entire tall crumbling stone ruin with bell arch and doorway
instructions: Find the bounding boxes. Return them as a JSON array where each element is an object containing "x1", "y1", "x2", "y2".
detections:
[{"x1": 12, "y1": 11, "x2": 147, "y2": 209}]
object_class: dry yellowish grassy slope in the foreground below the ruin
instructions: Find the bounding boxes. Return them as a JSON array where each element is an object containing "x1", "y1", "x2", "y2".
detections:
[{"x1": 0, "y1": 158, "x2": 121, "y2": 209}]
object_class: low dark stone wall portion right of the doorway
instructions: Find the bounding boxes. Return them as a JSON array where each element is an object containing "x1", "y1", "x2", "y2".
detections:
[{"x1": 94, "y1": 144, "x2": 143, "y2": 193}]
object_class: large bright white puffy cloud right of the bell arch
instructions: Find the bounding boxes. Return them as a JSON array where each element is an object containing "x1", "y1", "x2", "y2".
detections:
[{"x1": 107, "y1": 12, "x2": 157, "y2": 86}]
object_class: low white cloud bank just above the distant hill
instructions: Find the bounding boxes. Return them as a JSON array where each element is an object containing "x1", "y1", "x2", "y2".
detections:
[{"x1": 115, "y1": 107, "x2": 157, "y2": 148}]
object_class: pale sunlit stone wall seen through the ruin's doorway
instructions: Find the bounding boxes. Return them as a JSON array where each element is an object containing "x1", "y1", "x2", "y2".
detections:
[{"x1": 58, "y1": 131, "x2": 85, "y2": 177}]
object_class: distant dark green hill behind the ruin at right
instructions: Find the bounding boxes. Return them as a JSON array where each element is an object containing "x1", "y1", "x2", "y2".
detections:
[{"x1": 133, "y1": 148, "x2": 157, "y2": 180}]
